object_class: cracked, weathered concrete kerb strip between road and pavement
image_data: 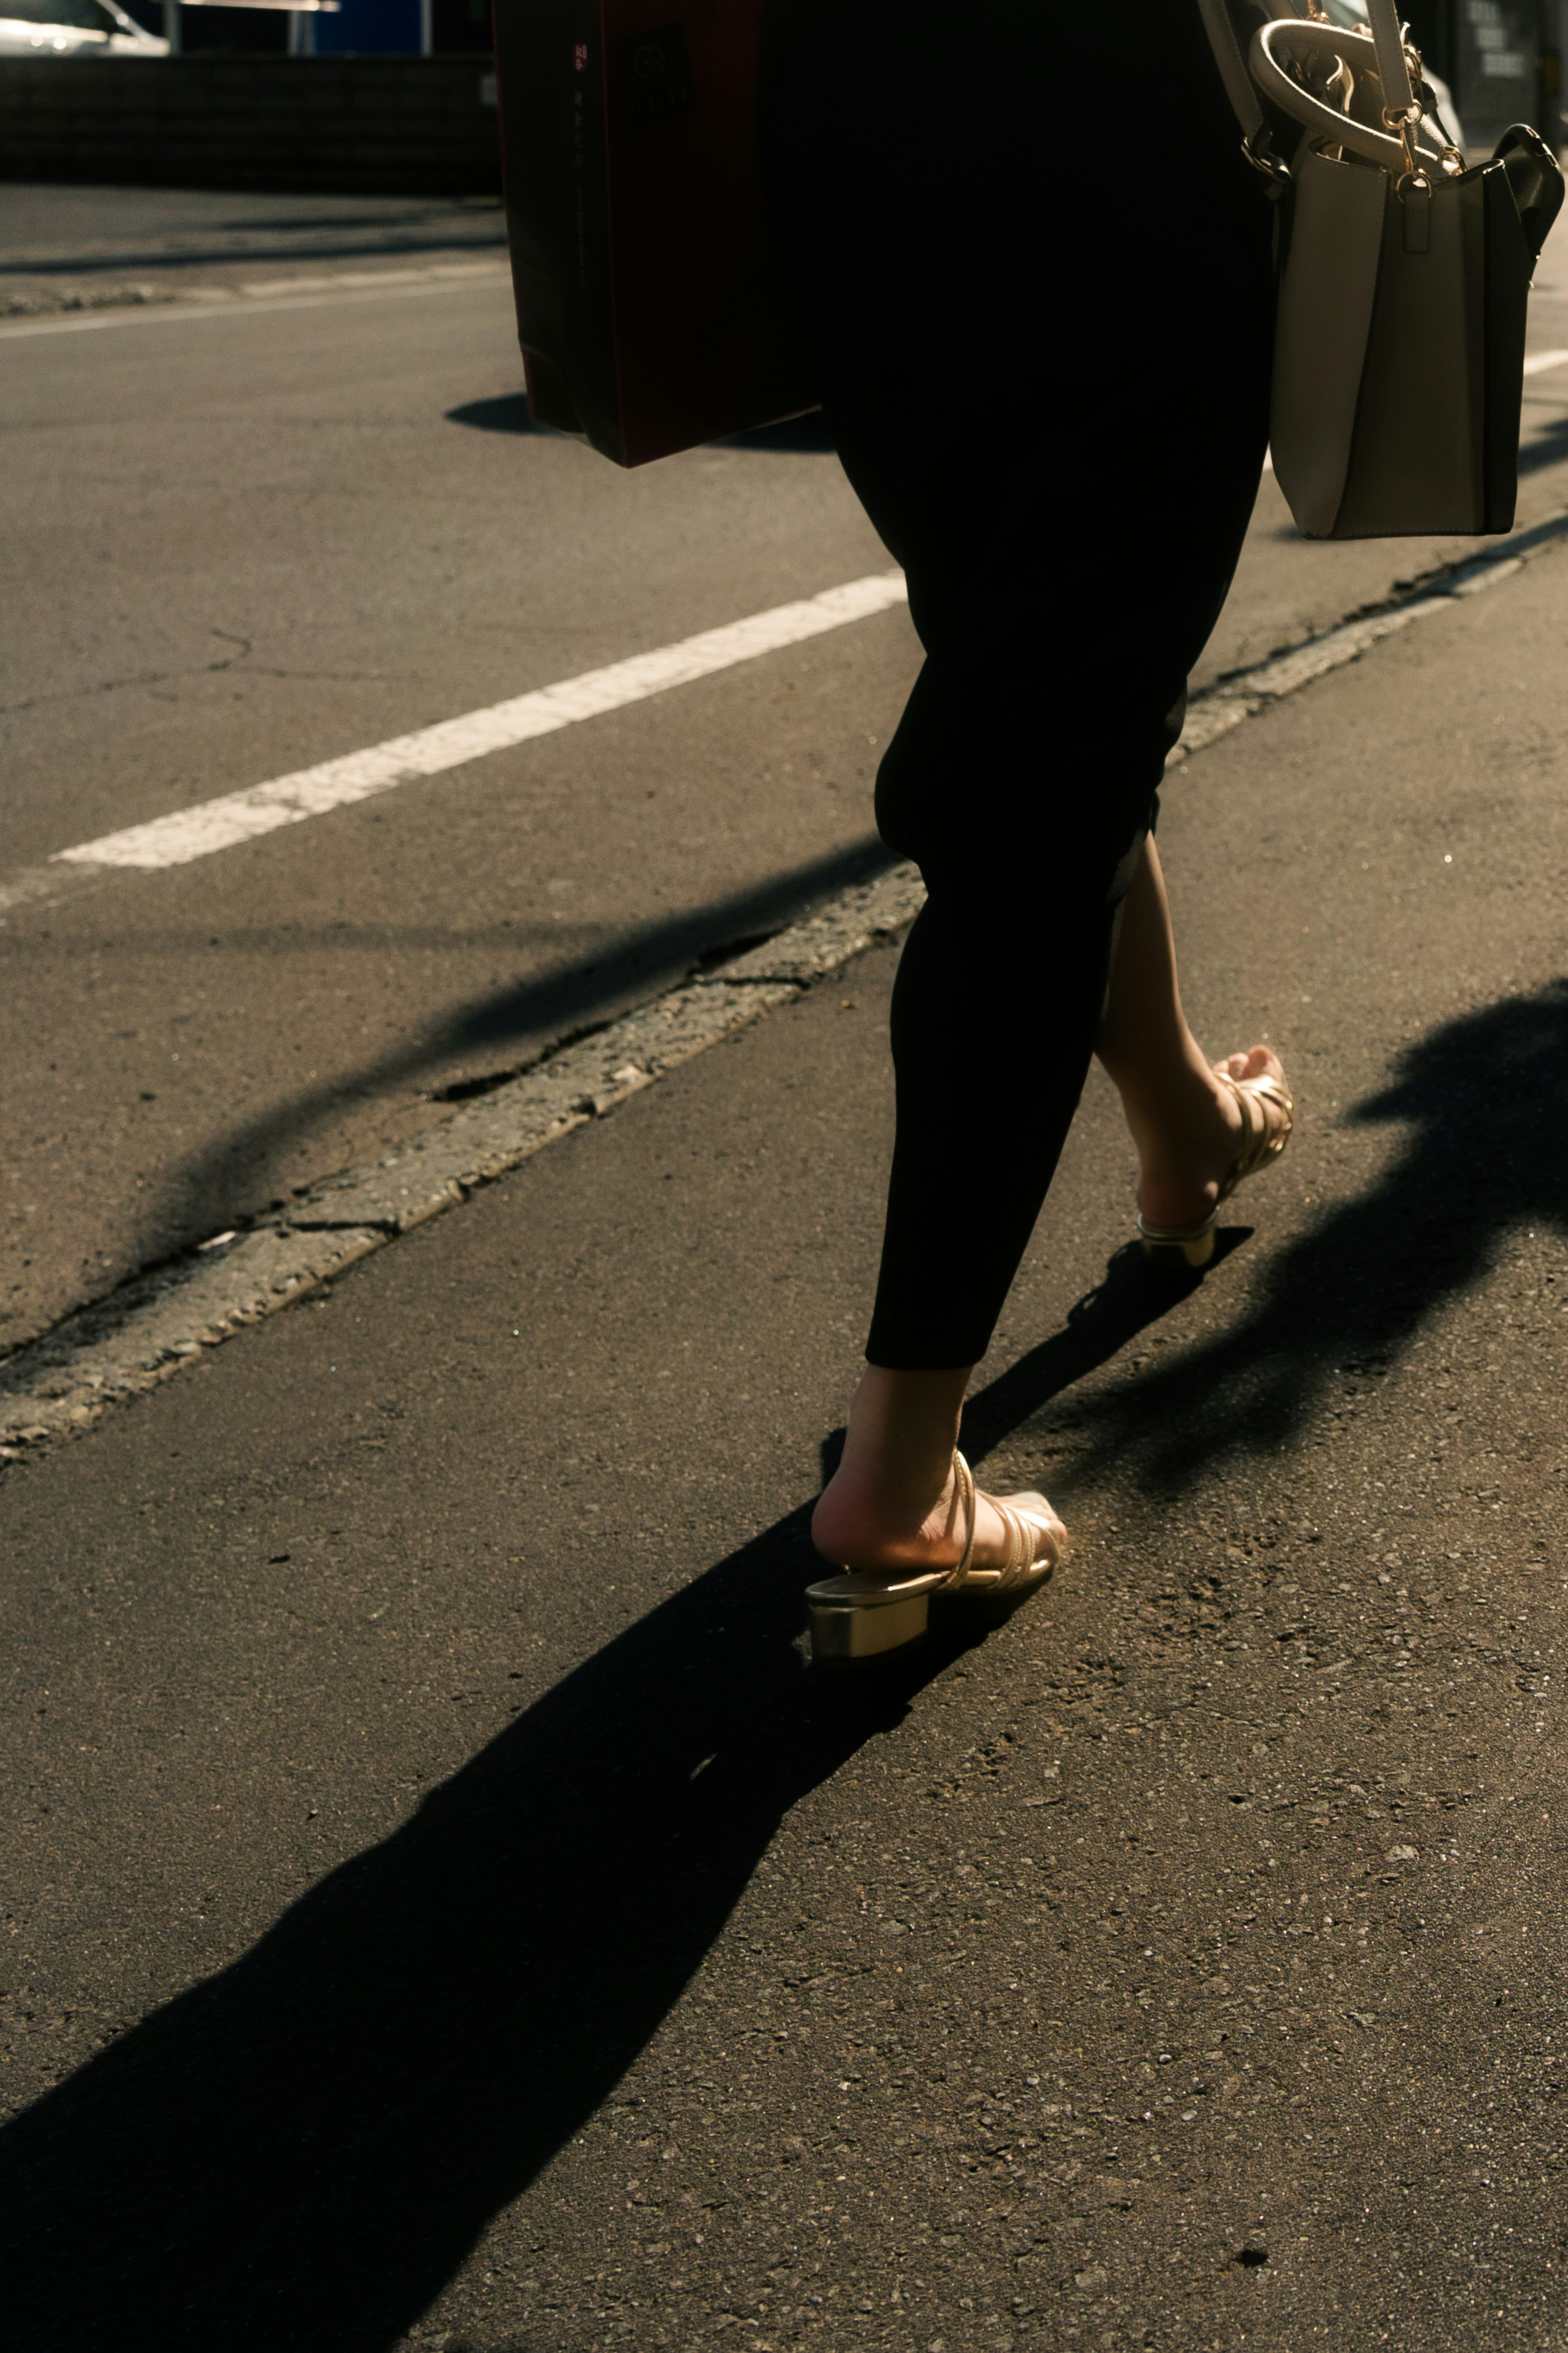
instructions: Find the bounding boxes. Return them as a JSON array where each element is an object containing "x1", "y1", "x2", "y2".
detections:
[{"x1": 0, "y1": 513, "x2": 1568, "y2": 1463}]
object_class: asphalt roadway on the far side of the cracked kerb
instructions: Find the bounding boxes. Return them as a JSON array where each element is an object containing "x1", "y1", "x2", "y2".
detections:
[{"x1": 0, "y1": 188, "x2": 1568, "y2": 1348}]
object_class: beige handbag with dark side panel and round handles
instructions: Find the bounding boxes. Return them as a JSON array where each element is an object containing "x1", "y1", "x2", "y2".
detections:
[{"x1": 1199, "y1": 0, "x2": 1563, "y2": 539}]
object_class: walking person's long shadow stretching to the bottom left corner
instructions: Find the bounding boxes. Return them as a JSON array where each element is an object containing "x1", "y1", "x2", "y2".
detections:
[{"x1": 0, "y1": 1252, "x2": 1189, "y2": 2353}]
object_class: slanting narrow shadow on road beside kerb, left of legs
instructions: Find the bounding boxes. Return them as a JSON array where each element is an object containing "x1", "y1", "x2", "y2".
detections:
[{"x1": 139, "y1": 835, "x2": 895, "y2": 1266}]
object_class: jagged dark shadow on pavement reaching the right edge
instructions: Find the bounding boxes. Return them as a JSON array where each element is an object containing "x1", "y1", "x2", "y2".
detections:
[{"x1": 971, "y1": 981, "x2": 1568, "y2": 1494}]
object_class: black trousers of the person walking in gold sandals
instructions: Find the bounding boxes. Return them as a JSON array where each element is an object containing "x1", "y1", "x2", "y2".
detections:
[{"x1": 764, "y1": 0, "x2": 1272, "y2": 1369}]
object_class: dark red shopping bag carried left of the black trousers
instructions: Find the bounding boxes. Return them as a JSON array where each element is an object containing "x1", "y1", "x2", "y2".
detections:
[{"x1": 496, "y1": 0, "x2": 816, "y2": 466}]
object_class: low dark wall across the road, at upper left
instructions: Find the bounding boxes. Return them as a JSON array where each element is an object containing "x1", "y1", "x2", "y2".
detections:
[{"x1": 0, "y1": 52, "x2": 501, "y2": 195}]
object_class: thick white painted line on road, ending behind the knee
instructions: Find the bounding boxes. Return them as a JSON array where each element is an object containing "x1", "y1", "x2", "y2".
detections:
[{"x1": 49, "y1": 572, "x2": 910, "y2": 868}]
